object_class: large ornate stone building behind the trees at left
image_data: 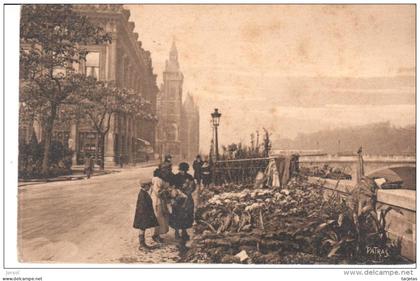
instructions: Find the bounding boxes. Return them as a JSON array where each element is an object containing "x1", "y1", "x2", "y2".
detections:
[{"x1": 20, "y1": 4, "x2": 159, "y2": 165}]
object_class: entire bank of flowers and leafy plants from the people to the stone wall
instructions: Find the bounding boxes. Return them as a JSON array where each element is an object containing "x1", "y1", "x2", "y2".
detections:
[{"x1": 182, "y1": 177, "x2": 402, "y2": 264}]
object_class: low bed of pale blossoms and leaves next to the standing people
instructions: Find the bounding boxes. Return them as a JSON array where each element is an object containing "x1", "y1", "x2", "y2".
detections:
[{"x1": 183, "y1": 178, "x2": 330, "y2": 263}]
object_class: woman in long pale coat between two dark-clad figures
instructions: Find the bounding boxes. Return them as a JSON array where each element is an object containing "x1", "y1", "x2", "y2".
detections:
[{"x1": 150, "y1": 164, "x2": 169, "y2": 242}]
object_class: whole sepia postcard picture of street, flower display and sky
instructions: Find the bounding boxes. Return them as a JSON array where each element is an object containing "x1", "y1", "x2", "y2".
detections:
[{"x1": 3, "y1": 3, "x2": 417, "y2": 280}]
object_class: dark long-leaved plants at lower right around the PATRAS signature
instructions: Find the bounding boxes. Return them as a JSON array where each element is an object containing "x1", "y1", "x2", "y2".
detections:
[{"x1": 316, "y1": 178, "x2": 399, "y2": 263}]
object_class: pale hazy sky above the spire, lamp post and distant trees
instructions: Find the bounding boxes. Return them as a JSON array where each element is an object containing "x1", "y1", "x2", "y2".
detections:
[{"x1": 127, "y1": 5, "x2": 415, "y2": 152}]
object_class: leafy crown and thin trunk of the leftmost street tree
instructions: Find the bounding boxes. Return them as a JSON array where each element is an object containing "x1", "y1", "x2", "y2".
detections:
[{"x1": 20, "y1": 5, "x2": 111, "y2": 175}]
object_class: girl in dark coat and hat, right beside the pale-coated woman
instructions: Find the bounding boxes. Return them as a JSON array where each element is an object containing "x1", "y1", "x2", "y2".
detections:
[{"x1": 169, "y1": 162, "x2": 196, "y2": 241}]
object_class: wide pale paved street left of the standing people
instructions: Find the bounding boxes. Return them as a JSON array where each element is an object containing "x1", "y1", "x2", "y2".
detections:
[{"x1": 18, "y1": 164, "x2": 185, "y2": 263}]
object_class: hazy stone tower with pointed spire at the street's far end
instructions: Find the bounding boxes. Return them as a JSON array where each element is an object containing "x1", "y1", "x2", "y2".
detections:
[{"x1": 156, "y1": 42, "x2": 199, "y2": 161}]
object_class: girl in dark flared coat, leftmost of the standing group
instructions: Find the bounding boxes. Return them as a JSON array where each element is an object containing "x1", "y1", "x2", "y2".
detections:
[{"x1": 133, "y1": 183, "x2": 159, "y2": 250}]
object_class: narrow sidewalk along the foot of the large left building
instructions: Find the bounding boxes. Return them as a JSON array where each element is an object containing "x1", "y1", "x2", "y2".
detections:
[{"x1": 18, "y1": 160, "x2": 159, "y2": 187}]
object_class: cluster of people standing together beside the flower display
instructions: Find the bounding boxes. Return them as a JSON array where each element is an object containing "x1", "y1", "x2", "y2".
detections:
[{"x1": 133, "y1": 155, "x2": 210, "y2": 250}]
